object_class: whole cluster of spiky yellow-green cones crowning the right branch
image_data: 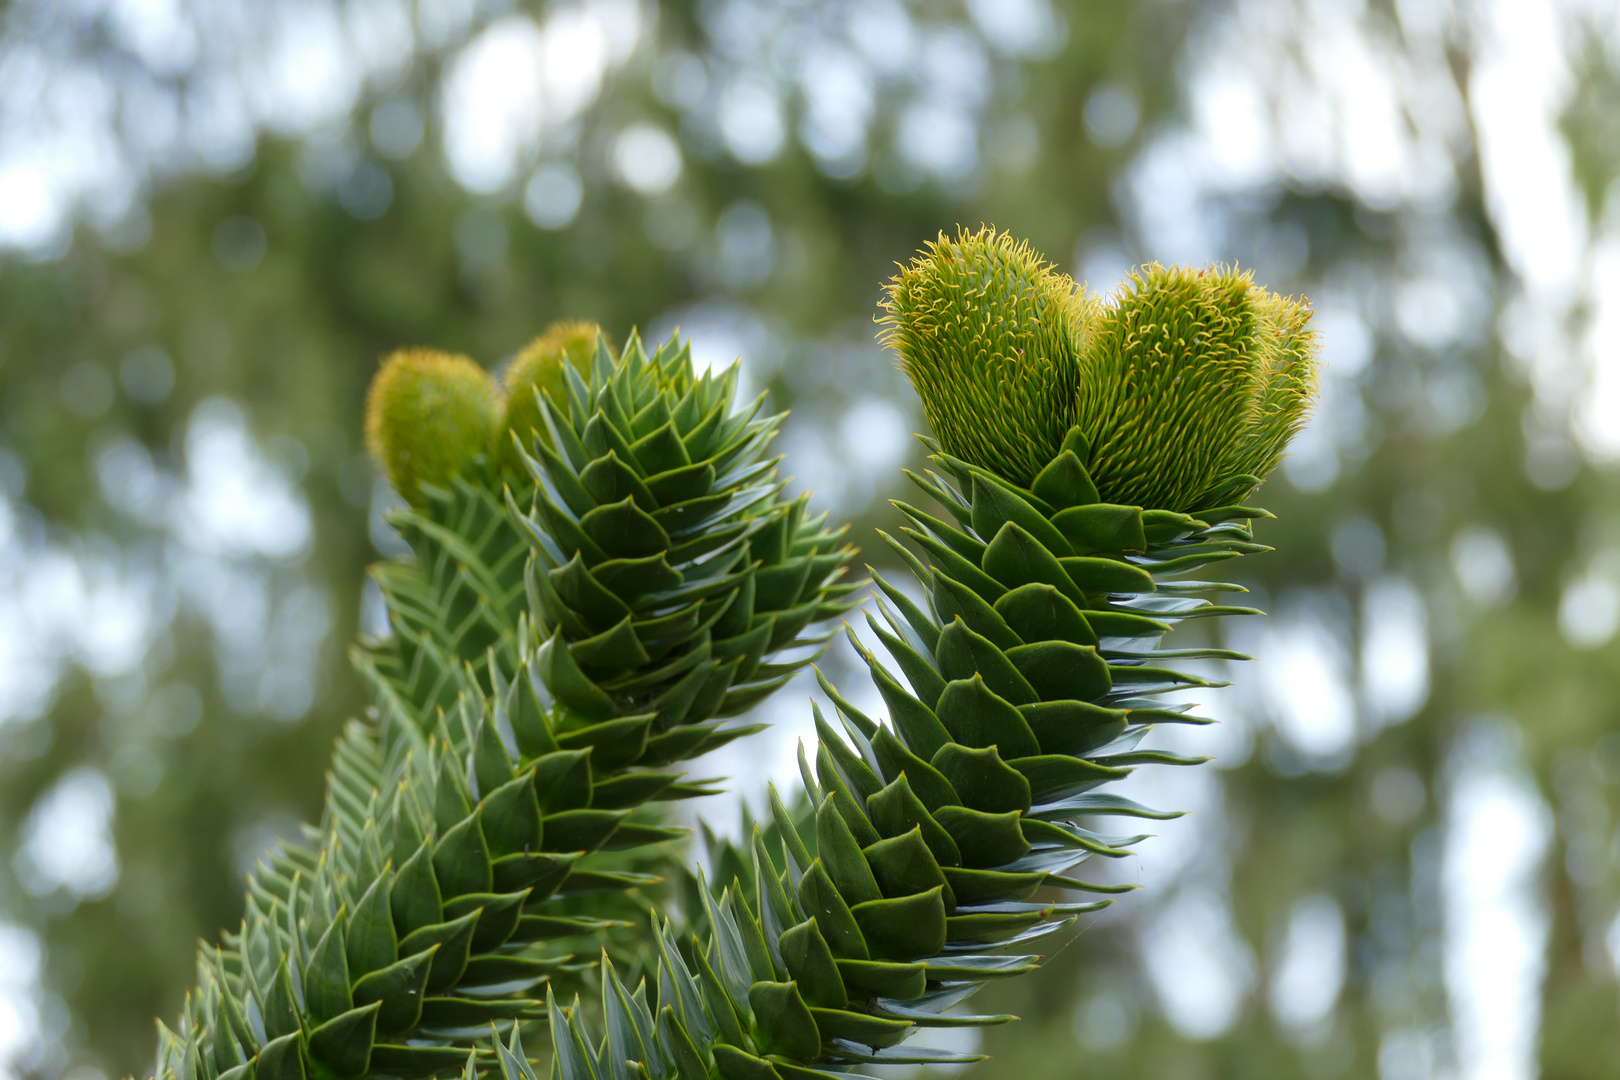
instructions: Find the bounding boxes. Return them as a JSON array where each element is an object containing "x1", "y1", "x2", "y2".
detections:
[{"x1": 883, "y1": 228, "x2": 1317, "y2": 512}]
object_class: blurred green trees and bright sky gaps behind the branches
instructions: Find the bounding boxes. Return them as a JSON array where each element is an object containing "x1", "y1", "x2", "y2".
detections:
[{"x1": 0, "y1": 0, "x2": 1620, "y2": 1080}]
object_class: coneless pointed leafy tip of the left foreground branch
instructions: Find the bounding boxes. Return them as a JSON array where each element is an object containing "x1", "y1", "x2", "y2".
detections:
[{"x1": 514, "y1": 337, "x2": 859, "y2": 748}]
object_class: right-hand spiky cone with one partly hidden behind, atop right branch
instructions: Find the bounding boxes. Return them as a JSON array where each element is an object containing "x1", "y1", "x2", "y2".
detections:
[{"x1": 1076, "y1": 264, "x2": 1317, "y2": 510}]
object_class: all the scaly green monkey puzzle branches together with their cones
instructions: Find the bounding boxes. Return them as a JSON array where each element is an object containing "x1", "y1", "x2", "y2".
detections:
[{"x1": 157, "y1": 228, "x2": 1315, "y2": 1080}]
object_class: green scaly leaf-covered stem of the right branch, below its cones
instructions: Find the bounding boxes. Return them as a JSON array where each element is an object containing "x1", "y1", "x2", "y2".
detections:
[{"x1": 524, "y1": 431, "x2": 1265, "y2": 1080}]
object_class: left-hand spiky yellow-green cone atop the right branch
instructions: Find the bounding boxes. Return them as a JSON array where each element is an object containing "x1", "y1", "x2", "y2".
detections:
[{"x1": 881, "y1": 227, "x2": 1094, "y2": 486}]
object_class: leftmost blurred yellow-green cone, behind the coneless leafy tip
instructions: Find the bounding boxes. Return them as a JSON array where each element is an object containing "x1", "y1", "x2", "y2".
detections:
[{"x1": 366, "y1": 348, "x2": 497, "y2": 505}]
